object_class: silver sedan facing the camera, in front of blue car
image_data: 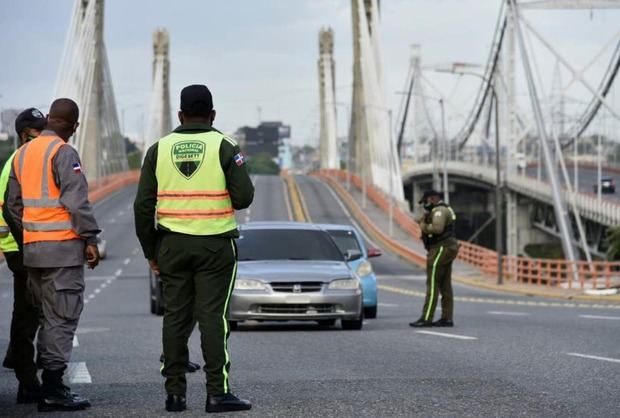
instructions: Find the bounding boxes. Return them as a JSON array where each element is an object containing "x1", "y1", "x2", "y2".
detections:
[{"x1": 229, "y1": 222, "x2": 364, "y2": 330}]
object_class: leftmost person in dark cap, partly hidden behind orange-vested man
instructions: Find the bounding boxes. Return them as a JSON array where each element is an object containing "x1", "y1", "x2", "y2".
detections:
[{"x1": 0, "y1": 107, "x2": 45, "y2": 403}]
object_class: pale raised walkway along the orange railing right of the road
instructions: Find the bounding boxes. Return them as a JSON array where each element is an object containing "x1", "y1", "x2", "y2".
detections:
[{"x1": 317, "y1": 170, "x2": 620, "y2": 303}]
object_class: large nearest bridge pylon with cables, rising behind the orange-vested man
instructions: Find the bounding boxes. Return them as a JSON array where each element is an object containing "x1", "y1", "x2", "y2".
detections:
[{"x1": 55, "y1": 0, "x2": 128, "y2": 180}]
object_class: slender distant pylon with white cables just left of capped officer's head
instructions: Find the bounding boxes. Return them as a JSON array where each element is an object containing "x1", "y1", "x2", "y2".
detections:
[{"x1": 144, "y1": 29, "x2": 172, "y2": 151}]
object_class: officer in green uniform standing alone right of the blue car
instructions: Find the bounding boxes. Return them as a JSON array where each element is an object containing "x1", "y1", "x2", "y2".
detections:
[{"x1": 409, "y1": 190, "x2": 458, "y2": 327}]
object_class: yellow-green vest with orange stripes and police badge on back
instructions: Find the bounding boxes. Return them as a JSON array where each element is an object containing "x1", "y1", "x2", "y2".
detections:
[{"x1": 155, "y1": 131, "x2": 237, "y2": 235}]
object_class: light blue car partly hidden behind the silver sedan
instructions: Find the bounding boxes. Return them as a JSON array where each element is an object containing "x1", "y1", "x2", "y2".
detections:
[{"x1": 319, "y1": 224, "x2": 381, "y2": 318}]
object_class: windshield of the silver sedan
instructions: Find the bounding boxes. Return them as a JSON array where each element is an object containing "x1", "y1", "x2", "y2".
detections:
[{"x1": 237, "y1": 229, "x2": 344, "y2": 261}]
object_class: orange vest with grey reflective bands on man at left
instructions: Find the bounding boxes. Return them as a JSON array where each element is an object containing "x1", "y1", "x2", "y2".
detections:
[{"x1": 13, "y1": 136, "x2": 80, "y2": 244}]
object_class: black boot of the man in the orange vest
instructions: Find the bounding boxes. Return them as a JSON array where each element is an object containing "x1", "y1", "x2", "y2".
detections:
[{"x1": 38, "y1": 369, "x2": 90, "y2": 412}]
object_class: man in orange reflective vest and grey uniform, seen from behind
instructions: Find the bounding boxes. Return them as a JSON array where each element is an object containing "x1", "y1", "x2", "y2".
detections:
[{"x1": 6, "y1": 99, "x2": 100, "y2": 411}]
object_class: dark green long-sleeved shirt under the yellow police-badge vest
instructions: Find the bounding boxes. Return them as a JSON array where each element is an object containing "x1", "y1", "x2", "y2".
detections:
[{"x1": 134, "y1": 123, "x2": 254, "y2": 259}]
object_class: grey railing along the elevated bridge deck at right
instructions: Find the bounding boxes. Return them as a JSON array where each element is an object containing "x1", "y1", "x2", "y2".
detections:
[{"x1": 403, "y1": 161, "x2": 620, "y2": 226}]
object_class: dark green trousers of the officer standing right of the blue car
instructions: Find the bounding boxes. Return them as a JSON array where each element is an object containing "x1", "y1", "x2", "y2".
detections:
[{"x1": 422, "y1": 239, "x2": 458, "y2": 321}]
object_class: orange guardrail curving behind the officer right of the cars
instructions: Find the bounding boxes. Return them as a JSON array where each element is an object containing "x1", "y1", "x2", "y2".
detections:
[{"x1": 315, "y1": 170, "x2": 620, "y2": 291}]
